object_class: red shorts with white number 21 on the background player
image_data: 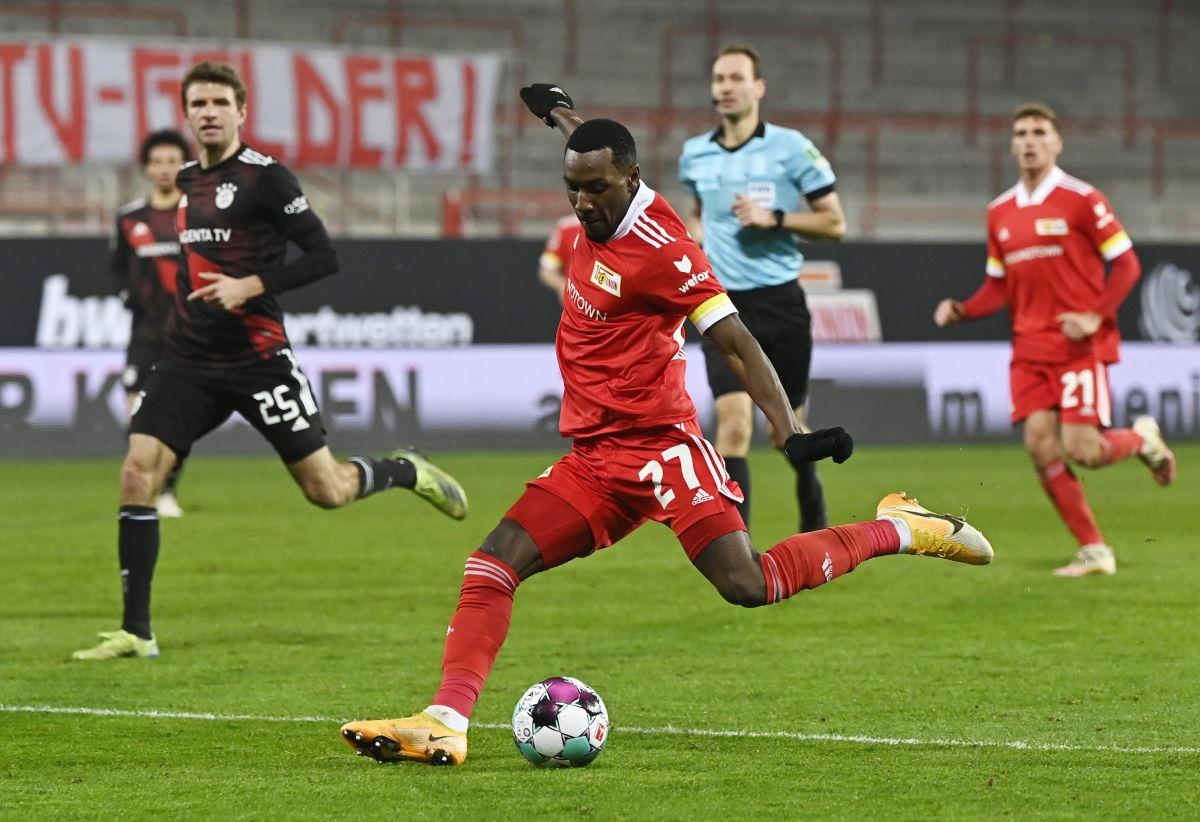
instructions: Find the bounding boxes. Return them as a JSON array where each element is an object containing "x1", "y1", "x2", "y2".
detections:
[{"x1": 1009, "y1": 356, "x2": 1112, "y2": 428}]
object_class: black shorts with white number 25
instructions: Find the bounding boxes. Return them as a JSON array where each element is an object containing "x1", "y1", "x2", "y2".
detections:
[{"x1": 130, "y1": 348, "x2": 325, "y2": 464}]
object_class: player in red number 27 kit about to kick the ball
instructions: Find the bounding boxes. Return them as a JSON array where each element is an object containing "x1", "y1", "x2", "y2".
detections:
[{"x1": 342, "y1": 84, "x2": 992, "y2": 764}]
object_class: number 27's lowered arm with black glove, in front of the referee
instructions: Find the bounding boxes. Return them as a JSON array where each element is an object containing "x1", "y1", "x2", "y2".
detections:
[{"x1": 706, "y1": 314, "x2": 854, "y2": 464}]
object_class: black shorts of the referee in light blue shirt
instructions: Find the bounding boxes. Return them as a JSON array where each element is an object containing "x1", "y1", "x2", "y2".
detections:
[{"x1": 703, "y1": 282, "x2": 812, "y2": 408}]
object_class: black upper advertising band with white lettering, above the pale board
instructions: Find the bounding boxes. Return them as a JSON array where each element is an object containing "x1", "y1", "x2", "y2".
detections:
[{"x1": 9, "y1": 239, "x2": 1200, "y2": 348}]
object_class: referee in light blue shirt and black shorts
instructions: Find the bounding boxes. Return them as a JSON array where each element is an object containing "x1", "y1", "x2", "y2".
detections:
[{"x1": 679, "y1": 46, "x2": 846, "y2": 532}]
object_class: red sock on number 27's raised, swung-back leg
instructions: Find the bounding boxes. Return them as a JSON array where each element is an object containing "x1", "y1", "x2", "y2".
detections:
[{"x1": 762, "y1": 522, "x2": 900, "y2": 605}]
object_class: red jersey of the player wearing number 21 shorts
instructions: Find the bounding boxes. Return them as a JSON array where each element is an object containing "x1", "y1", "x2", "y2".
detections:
[{"x1": 988, "y1": 167, "x2": 1133, "y2": 362}]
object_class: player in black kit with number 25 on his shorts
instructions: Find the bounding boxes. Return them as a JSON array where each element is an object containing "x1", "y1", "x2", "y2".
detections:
[{"x1": 73, "y1": 62, "x2": 467, "y2": 660}]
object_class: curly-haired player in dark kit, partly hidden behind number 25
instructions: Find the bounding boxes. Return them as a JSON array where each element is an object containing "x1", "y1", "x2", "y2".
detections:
[{"x1": 108, "y1": 128, "x2": 192, "y2": 517}]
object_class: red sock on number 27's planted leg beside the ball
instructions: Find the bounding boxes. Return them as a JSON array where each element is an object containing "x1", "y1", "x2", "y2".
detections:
[{"x1": 433, "y1": 551, "x2": 521, "y2": 716}]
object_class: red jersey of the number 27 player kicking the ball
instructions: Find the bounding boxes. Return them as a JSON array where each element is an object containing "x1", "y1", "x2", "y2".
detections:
[{"x1": 557, "y1": 182, "x2": 737, "y2": 438}]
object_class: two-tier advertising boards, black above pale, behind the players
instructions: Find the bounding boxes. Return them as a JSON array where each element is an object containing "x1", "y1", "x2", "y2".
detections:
[{"x1": 0, "y1": 239, "x2": 1200, "y2": 456}]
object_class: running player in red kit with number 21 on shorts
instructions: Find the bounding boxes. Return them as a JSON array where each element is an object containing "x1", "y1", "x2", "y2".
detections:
[{"x1": 934, "y1": 103, "x2": 1175, "y2": 577}]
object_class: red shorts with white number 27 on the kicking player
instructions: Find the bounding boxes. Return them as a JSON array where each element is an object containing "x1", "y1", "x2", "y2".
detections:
[{"x1": 505, "y1": 421, "x2": 746, "y2": 568}]
